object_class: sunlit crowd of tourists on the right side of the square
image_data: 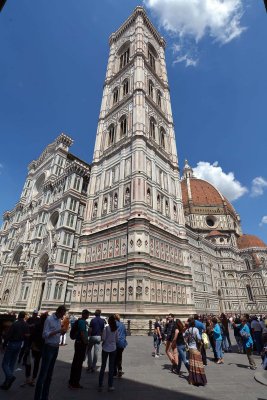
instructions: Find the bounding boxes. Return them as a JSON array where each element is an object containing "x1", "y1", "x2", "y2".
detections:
[{"x1": 153, "y1": 314, "x2": 267, "y2": 386}]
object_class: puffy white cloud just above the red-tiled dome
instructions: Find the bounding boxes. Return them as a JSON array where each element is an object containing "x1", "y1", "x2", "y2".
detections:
[{"x1": 193, "y1": 161, "x2": 248, "y2": 201}]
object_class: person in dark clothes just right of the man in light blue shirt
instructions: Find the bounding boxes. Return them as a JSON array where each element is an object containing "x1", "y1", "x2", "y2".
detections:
[{"x1": 69, "y1": 310, "x2": 89, "y2": 389}]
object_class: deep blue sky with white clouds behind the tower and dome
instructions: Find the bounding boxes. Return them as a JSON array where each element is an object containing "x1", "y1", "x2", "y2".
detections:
[{"x1": 0, "y1": 0, "x2": 267, "y2": 243}]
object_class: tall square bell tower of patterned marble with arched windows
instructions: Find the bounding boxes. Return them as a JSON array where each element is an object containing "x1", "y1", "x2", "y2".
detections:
[{"x1": 72, "y1": 7, "x2": 193, "y2": 326}]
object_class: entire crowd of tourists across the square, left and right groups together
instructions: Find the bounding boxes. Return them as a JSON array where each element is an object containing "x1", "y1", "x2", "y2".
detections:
[{"x1": 0, "y1": 305, "x2": 267, "y2": 400}]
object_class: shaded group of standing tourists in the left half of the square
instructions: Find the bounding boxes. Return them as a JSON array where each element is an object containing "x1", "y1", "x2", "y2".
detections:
[{"x1": 0, "y1": 306, "x2": 127, "y2": 400}]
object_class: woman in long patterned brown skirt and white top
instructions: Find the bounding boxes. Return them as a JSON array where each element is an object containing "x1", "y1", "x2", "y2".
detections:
[{"x1": 184, "y1": 318, "x2": 207, "y2": 386}]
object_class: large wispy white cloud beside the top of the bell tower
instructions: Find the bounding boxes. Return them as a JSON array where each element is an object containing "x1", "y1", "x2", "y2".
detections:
[{"x1": 143, "y1": 0, "x2": 246, "y2": 66}]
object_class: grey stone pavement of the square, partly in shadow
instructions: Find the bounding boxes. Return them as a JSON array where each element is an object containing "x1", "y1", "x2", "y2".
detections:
[{"x1": 0, "y1": 336, "x2": 267, "y2": 400}]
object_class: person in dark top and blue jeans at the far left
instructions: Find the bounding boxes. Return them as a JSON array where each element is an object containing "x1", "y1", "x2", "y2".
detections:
[{"x1": 0, "y1": 311, "x2": 30, "y2": 390}]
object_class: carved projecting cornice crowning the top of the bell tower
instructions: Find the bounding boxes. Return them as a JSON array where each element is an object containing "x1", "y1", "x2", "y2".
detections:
[{"x1": 109, "y1": 6, "x2": 166, "y2": 48}]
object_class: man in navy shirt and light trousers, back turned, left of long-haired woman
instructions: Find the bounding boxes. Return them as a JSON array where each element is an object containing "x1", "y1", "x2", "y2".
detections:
[{"x1": 87, "y1": 310, "x2": 105, "y2": 372}]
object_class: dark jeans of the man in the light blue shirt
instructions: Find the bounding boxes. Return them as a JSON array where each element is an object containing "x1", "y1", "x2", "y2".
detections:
[{"x1": 34, "y1": 344, "x2": 58, "y2": 400}]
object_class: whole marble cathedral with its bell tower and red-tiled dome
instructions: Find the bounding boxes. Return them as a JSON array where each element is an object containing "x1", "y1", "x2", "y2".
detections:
[{"x1": 0, "y1": 7, "x2": 267, "y2": 330}]
